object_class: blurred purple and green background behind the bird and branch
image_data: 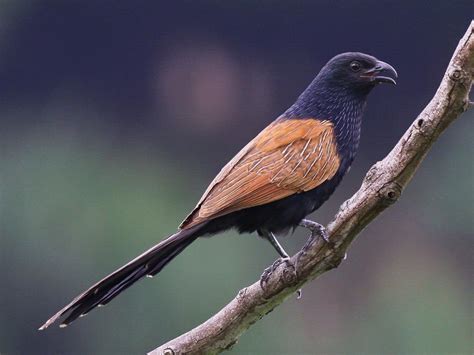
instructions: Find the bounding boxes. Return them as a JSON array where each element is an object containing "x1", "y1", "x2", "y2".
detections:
[{"x1": 0, "y1": 0, "x2": 474, "y2": 354}]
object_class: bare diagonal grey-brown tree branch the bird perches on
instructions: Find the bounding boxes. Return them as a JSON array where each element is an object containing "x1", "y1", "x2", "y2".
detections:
[{"x1": 149, "y1": 22, "x2": 474, "y2": 355}]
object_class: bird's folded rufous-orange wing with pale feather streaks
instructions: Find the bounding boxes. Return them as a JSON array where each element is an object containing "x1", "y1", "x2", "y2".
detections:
[{"x1": 180, "y1": 118, "x2": 340, "y2": 229}]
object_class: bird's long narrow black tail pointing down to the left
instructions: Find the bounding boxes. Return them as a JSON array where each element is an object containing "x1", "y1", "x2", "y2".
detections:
[{"x1": 39, "y1": 226, "x2": 200, "y2": 330}]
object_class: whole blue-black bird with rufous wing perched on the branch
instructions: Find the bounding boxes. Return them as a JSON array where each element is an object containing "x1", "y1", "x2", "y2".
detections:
[{"x1": 39, "y1": 52, "x2": 398, "y2": 330}]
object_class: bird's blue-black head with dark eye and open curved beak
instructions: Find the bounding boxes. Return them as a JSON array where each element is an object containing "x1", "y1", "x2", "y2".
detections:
[{"x1": 318, "y1": 52, "x2": 398, "y2": 92}]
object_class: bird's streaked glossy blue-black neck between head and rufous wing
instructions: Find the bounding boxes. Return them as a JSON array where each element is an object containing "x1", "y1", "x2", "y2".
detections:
[{"x1": 284, "y1": 78, "x2": 369, "y2": 164}]
